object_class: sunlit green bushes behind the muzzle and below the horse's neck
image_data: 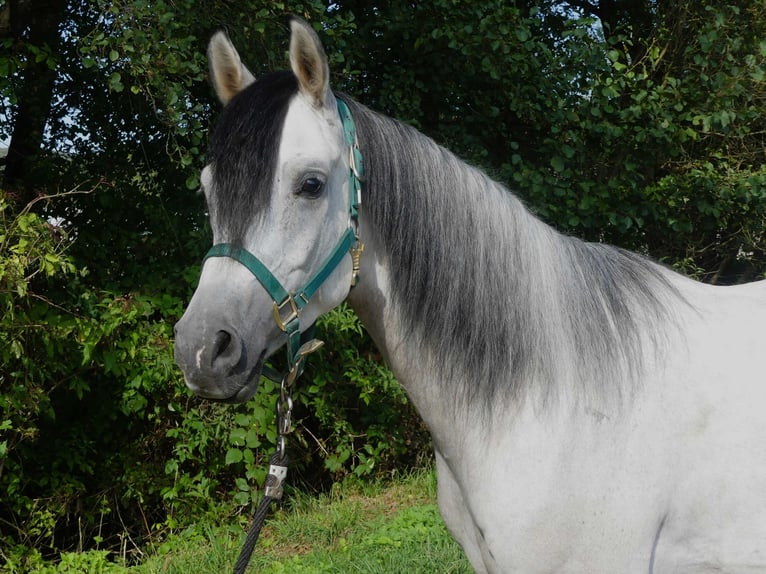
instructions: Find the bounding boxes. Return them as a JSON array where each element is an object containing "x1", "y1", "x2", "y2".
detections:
[{"x1": 0, "y1": 195, "x2": 427, "y2": 570}]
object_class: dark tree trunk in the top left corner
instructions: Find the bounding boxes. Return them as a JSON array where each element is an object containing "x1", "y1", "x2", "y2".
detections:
[{"x1": 3, "y1": 0, "x2": 66, "y2": 209}]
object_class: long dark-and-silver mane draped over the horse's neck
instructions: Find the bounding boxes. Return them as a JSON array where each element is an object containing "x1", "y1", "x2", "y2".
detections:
[{"x1": 339, "y1": 96, "x2": 681, "y2": 408}]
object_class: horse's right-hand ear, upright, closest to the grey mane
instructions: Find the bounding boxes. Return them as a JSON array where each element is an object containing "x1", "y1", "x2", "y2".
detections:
[{"x1": 290, "y1": 17, "x2": 333, "y2": 107}]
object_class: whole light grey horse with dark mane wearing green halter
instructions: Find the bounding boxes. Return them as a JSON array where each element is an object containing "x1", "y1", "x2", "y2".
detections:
[{"x1": 175, "y1": 15, "x2": 766, "y2": 574}]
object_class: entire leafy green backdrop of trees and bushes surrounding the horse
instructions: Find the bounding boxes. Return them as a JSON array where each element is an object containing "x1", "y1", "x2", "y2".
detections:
[{"x1": 0, "y1": 0, "x2": 766, "y2": 570}]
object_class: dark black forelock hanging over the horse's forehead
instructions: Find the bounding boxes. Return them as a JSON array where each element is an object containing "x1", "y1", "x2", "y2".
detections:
[{"x1": 208, "y1": 71, "x2": 298, "y2": 244}]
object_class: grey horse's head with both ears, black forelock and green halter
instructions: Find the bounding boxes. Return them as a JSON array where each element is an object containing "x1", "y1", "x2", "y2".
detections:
[{"x1": 175, "y1": 19, "x2": 356, "y2": 402}]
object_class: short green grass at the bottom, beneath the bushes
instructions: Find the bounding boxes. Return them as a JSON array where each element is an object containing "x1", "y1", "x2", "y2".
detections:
[{"x1": 136, "y1": 472, "x2": 472, "y2": 574}]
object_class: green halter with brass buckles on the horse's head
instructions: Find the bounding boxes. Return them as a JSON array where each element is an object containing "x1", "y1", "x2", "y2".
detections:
[{"x1": 203, "y1": 99, "x2": 364, "y2": 379}]
